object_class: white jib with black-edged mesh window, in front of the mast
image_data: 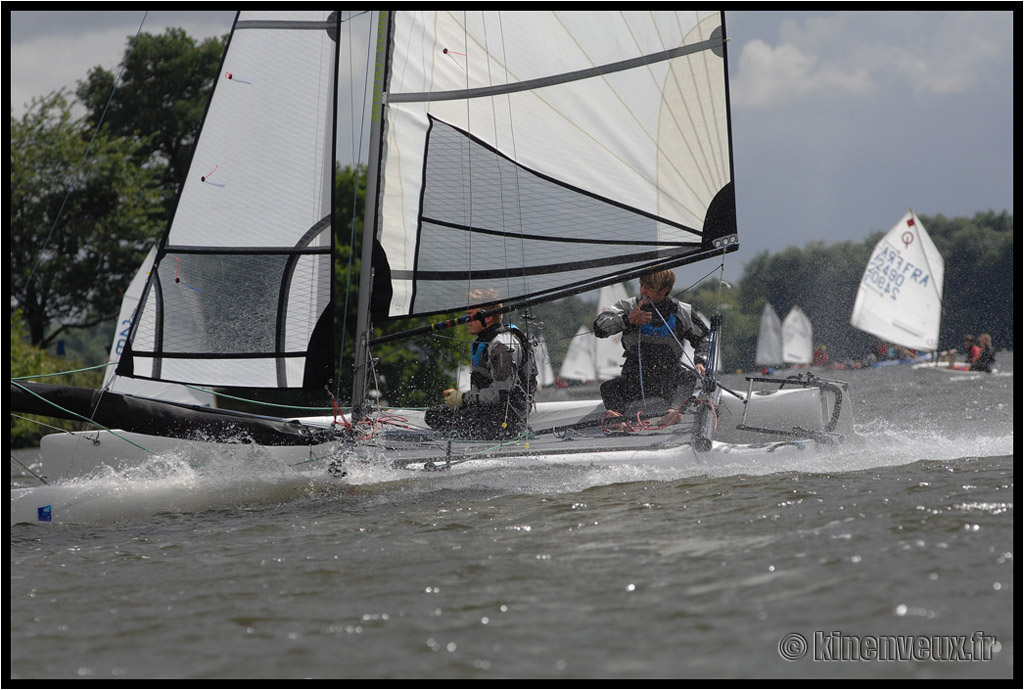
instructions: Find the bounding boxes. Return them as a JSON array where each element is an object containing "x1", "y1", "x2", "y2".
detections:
[{"x1": 118, "y1": 11, "x2": 338, "y2": 388}]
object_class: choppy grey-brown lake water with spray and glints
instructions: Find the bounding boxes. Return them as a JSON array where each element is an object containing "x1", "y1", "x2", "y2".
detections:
[{"x1": 8, "y1": 353, "x2": 1018, "y2": 682}]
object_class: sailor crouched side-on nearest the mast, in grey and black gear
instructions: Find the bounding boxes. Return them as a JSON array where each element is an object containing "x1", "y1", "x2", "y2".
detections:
[{"x1": 424, "y1": 292, "x2": 537, "y2": 439}]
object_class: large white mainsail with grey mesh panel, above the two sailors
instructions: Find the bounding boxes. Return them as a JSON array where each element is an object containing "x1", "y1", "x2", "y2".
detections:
[{"x1": 376, "y1": 10, "x2": 736, "y2": 317}]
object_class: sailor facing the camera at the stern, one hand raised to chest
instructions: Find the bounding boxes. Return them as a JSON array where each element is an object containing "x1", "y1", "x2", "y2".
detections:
[{"x1": 594, "y1": 270, "x2": 709, "y2": 427}]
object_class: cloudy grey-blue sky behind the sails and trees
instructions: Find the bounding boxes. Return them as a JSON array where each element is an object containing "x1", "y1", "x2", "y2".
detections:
[{"x1": 9, "y1": 10, "x2": 1019, "y2": 284}]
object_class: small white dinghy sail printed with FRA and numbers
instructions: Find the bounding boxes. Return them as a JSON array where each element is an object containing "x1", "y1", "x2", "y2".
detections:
[{"x1": 850, "y1": 210, "x2": 945, "y2": 350}]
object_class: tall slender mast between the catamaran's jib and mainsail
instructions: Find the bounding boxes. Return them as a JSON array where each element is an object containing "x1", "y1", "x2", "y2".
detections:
[{"x1": 351, "y1": 10, "x2": 391, "y2": 416}]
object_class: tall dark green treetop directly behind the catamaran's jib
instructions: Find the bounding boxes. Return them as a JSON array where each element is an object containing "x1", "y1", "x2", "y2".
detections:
[{"x1": 77, "y1": 28, "x2": 226, "y2": 211}]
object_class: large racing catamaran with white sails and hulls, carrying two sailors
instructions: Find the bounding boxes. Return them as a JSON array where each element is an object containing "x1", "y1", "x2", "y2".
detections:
[{"x1": 11, "y1": 10, "x2": 851, "y2": 519}]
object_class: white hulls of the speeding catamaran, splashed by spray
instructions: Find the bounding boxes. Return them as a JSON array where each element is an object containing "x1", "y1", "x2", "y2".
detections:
[{"x1": 11, "y1": 372, "x2": 852, "y2": 523}]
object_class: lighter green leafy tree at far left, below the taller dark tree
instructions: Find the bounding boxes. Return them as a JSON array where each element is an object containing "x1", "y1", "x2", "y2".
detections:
[{"x1": 8, "y1": 91, "x2": 160, "y2": 347}]
